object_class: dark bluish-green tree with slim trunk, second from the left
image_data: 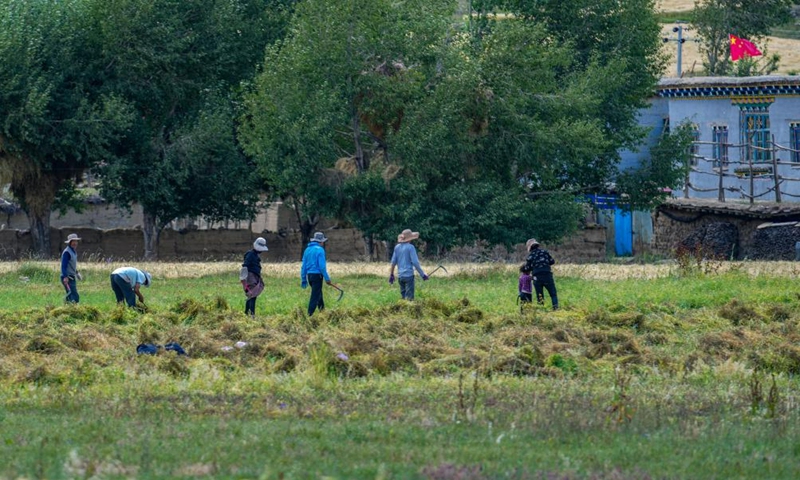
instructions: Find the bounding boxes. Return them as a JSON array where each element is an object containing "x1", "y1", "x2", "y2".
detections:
[{"x1": 95, "y1": 0, "x2": 293, "y2": 258}]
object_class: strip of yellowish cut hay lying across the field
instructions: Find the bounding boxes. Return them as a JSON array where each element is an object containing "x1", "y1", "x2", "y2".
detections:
[{"x1": 0, "y1": 290, "x2": 800, "y2": 385}]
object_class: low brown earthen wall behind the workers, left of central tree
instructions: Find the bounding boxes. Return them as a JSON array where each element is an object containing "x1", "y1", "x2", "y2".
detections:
[{"x1": 0, "y1": 228, "x2": 386, "y2": 262}]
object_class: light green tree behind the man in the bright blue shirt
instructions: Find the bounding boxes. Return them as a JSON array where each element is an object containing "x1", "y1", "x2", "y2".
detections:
[{"x1": 241, "y1": 0, "x2": 453, "y2": 253}]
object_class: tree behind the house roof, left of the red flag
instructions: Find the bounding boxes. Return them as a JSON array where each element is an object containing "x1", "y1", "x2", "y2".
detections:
[{"x1": 692, "y1": 0, "x2": 793, "y2": 75}]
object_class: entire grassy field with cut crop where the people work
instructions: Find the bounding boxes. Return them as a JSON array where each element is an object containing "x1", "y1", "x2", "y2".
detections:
[{"x1": 0, "y1": 262, "x2": 800, "y2": 480}]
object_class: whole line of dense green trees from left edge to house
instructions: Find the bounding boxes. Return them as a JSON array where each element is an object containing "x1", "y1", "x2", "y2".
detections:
[{"x1": 0, "y1": 0, "x2": 680, "y2": 256}]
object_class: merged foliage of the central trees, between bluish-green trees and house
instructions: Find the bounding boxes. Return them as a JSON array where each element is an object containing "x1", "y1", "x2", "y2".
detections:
[{"x1": 241, "y1": 0, "x2": 663, "y2": 255}]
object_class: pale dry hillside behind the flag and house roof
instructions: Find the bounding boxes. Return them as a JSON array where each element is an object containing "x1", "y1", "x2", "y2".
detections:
[{"x1": 657, "y1": 0, "x2": 800, "y2": 77}]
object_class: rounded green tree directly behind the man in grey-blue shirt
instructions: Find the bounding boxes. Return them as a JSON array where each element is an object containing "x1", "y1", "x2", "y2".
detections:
[{"x1": 381, "y1": 20, "x2": 607, "y2": 252}]
